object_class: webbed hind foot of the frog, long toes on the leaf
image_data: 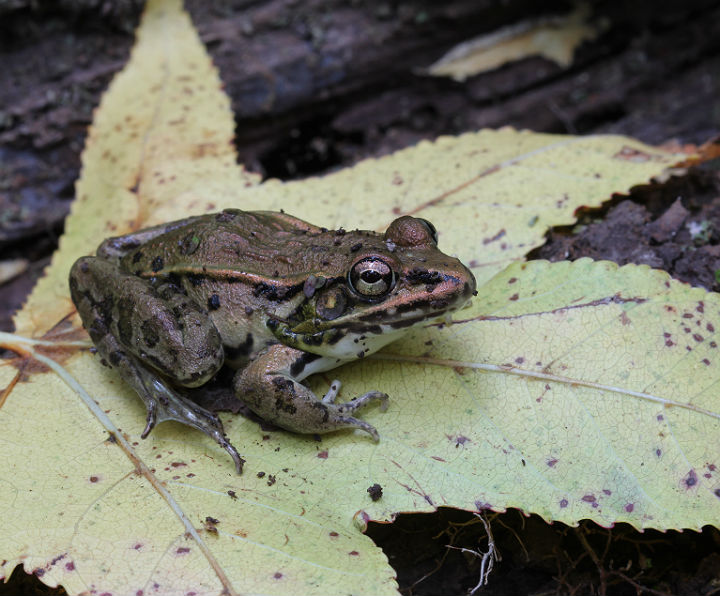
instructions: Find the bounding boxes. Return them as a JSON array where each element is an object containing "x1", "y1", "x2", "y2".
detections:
[{"x1": 138, "y1": 369, "x2": 245, "y2": 474}]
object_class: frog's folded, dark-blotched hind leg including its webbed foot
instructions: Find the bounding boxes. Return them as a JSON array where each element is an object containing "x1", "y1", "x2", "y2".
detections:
[{"x1": 70, "y1": 257, "x2": 243, "y2": 473}]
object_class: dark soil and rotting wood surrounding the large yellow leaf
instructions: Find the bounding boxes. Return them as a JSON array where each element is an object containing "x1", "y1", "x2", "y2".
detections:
[{"x1": 0, "y1": 0, "x2": 720, "y2": 595}]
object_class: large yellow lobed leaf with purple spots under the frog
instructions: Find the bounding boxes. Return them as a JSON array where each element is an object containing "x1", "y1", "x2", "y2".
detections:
[{"x1": 0, "y1": 0, "x2": 704, "y2": 594}]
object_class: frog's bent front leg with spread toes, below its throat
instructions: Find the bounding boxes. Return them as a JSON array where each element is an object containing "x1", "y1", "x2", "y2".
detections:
[{"x1": 233, "y1": 344, "x2": 388, "y2": 441}]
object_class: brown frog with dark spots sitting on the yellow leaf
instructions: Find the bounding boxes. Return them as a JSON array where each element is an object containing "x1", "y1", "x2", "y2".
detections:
[{"x1": 69, "y1": 209, "x2": 476, "y2": 473}]
